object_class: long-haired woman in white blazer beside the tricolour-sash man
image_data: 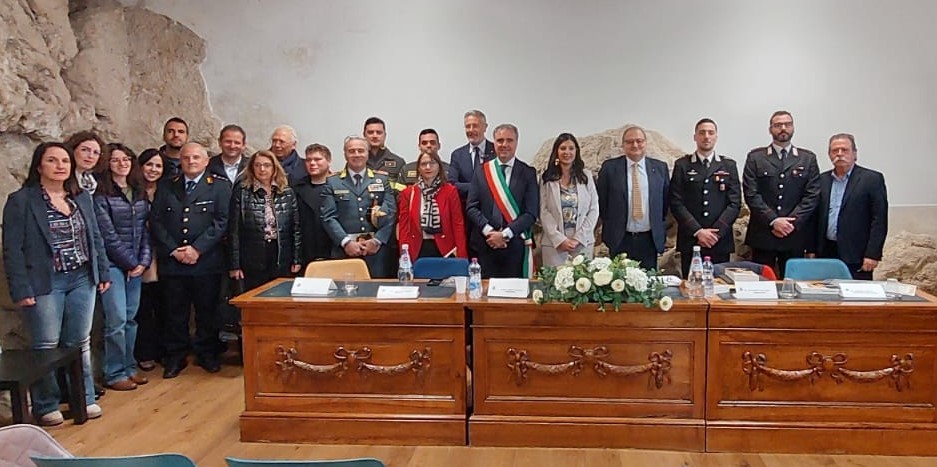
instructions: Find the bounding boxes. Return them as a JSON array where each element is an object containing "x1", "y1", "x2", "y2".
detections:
[{"x1": 540, "y1": 133, "x2": 599, "y2": 266}]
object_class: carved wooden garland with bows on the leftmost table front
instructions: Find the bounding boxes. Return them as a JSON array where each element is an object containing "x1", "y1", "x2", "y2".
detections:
[{"x1": 274, "y1": 345, "x2": 432, "y2": 378}]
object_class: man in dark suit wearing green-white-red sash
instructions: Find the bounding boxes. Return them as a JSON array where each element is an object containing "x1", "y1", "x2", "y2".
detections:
[{"x1": 467, "y1": 123, "x2": 540, "y2": 277}]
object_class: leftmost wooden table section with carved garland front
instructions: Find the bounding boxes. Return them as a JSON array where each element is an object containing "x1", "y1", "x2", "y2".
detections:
[{"x1": 232, "y1": 279, "x2": 466, "y2": 445}]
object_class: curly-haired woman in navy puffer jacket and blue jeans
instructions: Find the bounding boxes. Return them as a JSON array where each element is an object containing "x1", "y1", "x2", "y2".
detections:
[{"x1": 94, "y1": 143, "x2": 152, "y2": 391}]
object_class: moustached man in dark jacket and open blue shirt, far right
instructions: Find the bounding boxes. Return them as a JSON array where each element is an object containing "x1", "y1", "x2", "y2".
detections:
[{"x1": 808, "y1": 133, "x2": 888, "y2": 280}]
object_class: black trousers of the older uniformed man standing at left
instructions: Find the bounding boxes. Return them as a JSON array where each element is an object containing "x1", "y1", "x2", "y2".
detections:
[{"x1": 160, "y1": 274, "x2": 224, "y2": 363}]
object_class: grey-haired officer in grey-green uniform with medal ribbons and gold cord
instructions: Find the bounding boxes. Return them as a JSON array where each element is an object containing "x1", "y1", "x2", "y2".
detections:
[{"x1": 322, "y1": 136, "x2": 397, "y2": 278}]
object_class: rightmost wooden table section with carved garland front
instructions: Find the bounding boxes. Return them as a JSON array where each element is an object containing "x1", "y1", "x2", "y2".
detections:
[{"x1": 706, "y1": 294, "x2": 937, "y2": 455}]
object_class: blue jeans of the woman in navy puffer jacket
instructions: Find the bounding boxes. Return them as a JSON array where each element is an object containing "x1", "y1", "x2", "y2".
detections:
[{"x1": 101, "y1": 265, "x2": 143, "y2": 384}]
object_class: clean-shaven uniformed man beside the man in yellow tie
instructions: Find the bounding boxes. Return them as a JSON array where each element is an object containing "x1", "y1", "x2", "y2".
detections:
[{"x1": 670, "y1": 118, "x2": 742, "y2": 277}]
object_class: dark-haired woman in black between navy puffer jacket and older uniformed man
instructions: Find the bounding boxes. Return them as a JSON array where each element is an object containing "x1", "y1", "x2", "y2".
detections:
[{"x1": 134, "y1": 148, "x2": 164, "y2": 371}]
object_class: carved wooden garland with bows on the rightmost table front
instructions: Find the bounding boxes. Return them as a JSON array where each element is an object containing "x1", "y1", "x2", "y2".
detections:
[{"x1": 742, "y1": 352, "x2": 914, "y2": 392}]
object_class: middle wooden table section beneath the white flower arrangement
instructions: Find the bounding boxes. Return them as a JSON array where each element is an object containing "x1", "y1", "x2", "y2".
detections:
[{"x1": 466, "y1": 299, "x2": 708, "y2": 451}]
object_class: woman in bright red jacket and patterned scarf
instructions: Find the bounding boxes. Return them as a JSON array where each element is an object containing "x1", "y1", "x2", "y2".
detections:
[{"x1": 397, "y1": 151, "x2": 468, "y2": 261}]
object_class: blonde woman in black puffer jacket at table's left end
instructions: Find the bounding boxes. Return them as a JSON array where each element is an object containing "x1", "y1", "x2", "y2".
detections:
[{"x1": 228, "y1": 151, "x2": 302, "y2": 290}]
